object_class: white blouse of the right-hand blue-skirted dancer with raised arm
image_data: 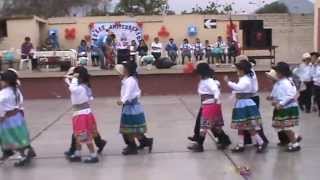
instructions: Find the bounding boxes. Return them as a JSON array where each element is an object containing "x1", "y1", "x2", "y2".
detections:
[{"x1": 228, "y1": 75, "x2": 254, "y2": 93}]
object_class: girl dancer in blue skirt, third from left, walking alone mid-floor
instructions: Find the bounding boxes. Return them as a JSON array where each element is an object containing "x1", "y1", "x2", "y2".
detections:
[{"x1": 116, "y1": 62, "x2": 153, "y2": 155}]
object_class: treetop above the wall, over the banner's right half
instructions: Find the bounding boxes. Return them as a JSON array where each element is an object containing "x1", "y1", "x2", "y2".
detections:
[{"x1": 115, "y1": 0, "x2": 169, "y2": 15}]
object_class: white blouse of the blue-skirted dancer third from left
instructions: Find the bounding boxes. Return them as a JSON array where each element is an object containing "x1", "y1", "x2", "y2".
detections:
[{"x1": 120, "y1": 76, "x2": 141, "y2": 103}]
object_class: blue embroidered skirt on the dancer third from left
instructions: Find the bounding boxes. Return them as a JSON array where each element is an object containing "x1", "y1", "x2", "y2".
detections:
[{"x1": 120, "y1": 99, "x2": 147, "y2": 134}]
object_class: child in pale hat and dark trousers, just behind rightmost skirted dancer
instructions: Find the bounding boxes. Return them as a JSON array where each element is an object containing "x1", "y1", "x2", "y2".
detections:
[{"x1": 294, "y1": 53, "x2": 313, "y2": 113}]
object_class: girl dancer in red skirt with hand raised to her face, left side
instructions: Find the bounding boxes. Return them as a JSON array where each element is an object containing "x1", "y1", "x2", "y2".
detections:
[{"x1": 65, "y1": 66, "x2": 99, "y2": 163}]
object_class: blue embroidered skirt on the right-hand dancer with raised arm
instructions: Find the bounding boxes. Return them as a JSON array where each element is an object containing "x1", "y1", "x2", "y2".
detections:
[{"x1": 231, "y1": 99, "x2": 261, "y2": 130}]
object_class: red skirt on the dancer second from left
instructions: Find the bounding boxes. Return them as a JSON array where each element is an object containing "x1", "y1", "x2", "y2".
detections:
[{"x1": 72, "y1": 113, "x2": 97, "y2": 143}]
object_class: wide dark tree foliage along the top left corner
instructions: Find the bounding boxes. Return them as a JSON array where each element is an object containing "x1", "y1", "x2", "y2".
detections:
[{"x1": 1, "y1": 0, "x2": 100, "y2": 17}]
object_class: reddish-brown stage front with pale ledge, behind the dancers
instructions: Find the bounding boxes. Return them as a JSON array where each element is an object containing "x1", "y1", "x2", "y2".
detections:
[{"x1": 20, "y1": 65, "x2": 271, "y2": 99}]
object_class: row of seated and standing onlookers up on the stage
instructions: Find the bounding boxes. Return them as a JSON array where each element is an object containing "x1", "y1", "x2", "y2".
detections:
[{"x1": 16, "y1": 30, "x2": 239, "y2": 69}]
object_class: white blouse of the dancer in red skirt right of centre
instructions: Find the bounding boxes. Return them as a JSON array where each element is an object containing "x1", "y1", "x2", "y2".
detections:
[{"x1": 198, "y1": 78, "x2": 221, "y2": 103}]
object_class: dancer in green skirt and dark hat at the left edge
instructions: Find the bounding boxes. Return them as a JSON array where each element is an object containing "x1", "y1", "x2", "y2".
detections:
[{"x1": 0, "y1": 70, "x2": 35, "y2": 167}]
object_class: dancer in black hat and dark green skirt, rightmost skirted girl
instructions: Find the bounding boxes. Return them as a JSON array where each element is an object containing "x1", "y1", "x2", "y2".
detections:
[{"x1": 268, "y1": 62, "x2": 301, "y2": 152}]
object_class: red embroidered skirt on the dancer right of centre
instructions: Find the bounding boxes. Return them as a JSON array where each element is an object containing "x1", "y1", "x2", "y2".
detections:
[{"x1": 200, "y1": 104, "x2": 224, "y2": 130}]
